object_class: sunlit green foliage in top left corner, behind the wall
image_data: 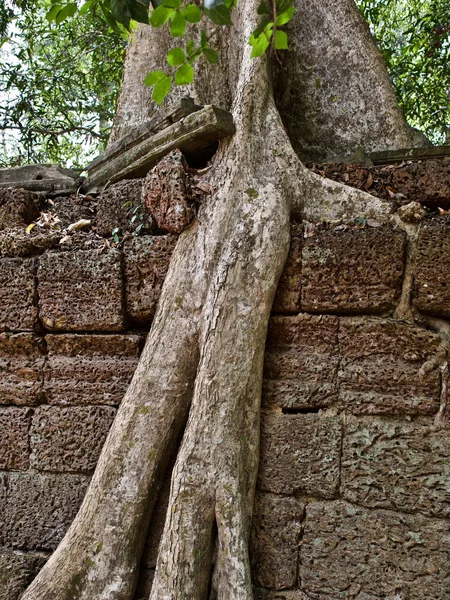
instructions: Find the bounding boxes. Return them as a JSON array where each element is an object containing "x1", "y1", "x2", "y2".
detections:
[{"x1": 0, "y1": 0, "x2": 125, "y2": 167}]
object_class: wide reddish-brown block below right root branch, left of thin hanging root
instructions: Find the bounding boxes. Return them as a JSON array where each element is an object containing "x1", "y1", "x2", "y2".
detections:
[{"x1": 301, "y1": 226, "x2": 405, "y2": 314}]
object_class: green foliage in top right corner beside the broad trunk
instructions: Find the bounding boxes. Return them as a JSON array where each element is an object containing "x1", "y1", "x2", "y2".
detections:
[{"x1": 357, "y1": 0, "x2": 450, "y2": 143}]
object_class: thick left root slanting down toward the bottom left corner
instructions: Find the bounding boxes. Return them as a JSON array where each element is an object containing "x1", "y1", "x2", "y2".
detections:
[{"x1": 23, "y1": 228, "x2": 201, "y2": 600}]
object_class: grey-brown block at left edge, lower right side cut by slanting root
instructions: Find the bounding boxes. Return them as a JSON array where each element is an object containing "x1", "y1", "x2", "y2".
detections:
[{"x1": 2, "y1": 473, "x2": 89, "y2": 550}]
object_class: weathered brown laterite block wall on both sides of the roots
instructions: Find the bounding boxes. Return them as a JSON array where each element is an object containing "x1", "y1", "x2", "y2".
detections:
[{"x1": 0, "y1": 171, "x2": 450, "y2": 600}]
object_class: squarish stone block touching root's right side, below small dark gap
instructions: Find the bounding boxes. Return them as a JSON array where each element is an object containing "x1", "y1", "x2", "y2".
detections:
[{"x1": 258, "y1": 414, "x2": 342, "y2": 498}]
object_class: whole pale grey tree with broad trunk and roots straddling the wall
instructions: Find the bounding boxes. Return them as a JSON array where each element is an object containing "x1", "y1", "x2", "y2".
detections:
[{"x1": 23, "y1": 0, "x2": 418, "y2": 600}]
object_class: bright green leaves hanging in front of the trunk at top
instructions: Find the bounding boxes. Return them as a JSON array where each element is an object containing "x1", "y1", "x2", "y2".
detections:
[{"x1": 47, "y1": 0, "x2": 295, "y2": 104}]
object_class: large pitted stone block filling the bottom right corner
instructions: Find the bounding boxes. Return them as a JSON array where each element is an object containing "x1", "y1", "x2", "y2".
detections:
[{"x1": 300, "y1": 501, "x2": 450, "y2": 600}]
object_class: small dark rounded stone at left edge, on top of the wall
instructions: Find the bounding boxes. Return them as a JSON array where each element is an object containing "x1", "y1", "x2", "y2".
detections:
[{"x1": 0, "y1": 189, "x2": 39, "y2": 230}]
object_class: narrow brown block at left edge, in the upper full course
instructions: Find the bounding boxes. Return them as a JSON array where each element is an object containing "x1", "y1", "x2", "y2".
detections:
[{"x1": 0, "y1": 258, "x2": 38, "y2": 331}]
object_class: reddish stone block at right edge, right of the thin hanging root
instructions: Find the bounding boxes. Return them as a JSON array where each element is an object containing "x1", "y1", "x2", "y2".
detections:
[{"x1": 413, "y1": 218, "x2": 450, "y2": 318}]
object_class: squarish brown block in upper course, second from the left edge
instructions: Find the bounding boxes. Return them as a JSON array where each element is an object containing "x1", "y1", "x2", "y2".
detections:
[{"x1": 38, "y1": 249, "x2": 124, "y2": 331}]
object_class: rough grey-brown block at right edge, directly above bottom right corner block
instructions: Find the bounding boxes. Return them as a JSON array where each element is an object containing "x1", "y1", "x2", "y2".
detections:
[{"x1": 341, "y1": 418, "x2": 450, "y2": 518}]
